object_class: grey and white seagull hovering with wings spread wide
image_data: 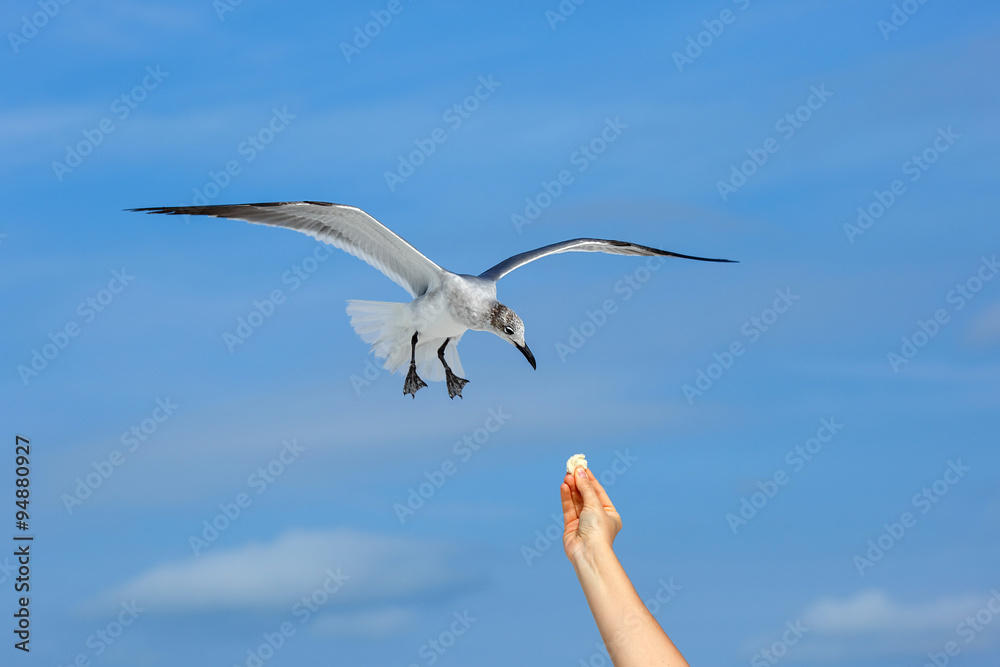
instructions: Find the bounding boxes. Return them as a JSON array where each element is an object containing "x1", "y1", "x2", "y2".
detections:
[{"x1": 133, "y1": 201, "x2": 733, "y2": 399}]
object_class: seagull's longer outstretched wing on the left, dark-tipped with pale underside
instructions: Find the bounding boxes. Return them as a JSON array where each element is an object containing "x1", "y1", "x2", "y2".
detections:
[{"x1": 128, "y1": 201, "x2": 445, "y2": 297}]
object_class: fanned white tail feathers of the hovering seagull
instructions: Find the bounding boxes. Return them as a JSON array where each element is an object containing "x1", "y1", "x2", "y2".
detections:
[{"x1": 347, "y1": 300, "x2": 464, "y2": 381}]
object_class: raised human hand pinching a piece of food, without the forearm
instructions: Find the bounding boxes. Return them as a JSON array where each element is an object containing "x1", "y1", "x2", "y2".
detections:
[{"x1": 559, "y1": 467, "x2": 622, "y2": 565}]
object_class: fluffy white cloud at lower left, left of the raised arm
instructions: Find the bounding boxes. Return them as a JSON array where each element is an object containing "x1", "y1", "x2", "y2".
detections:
[{"x1": 95, "y1": 529, "x2": 475, "y2": 621}]
